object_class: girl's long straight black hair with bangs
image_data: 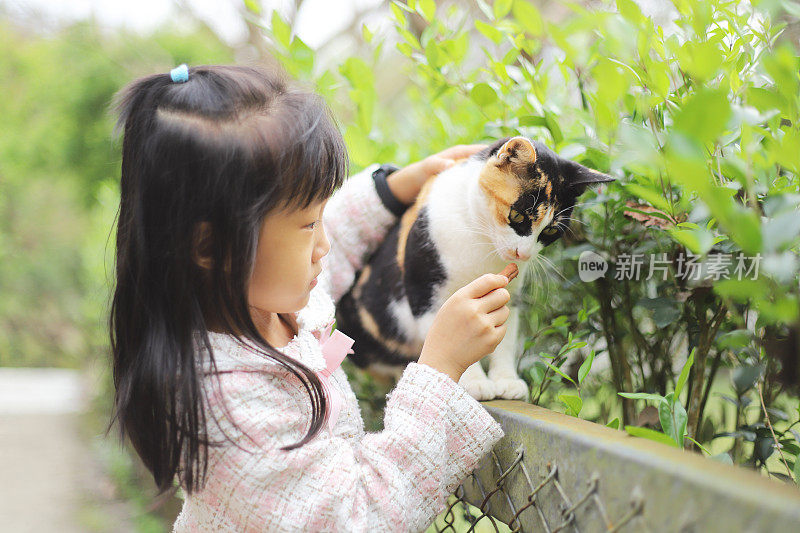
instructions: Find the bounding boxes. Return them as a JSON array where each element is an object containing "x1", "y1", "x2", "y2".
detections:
[{"x1": 109, "y1": 66, "x2": 347, "y2": 493}]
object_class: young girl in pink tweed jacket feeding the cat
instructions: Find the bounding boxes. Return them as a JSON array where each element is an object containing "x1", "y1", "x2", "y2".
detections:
[{"x1": 110, "y1": 65, "x2": 509, "y2": 531}]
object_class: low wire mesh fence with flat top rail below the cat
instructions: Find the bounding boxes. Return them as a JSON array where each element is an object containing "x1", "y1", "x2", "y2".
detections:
[{"x1": 428, "y1": 401, "x2": 800, "y2": 533}]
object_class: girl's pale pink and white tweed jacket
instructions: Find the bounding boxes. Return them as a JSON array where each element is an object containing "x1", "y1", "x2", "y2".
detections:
[{"x1": 174, "y1": 166, "x2": 504, "y2": 532}]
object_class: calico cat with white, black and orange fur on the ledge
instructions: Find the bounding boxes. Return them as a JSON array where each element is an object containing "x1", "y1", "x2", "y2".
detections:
[{"x1": 336, "y1": 137, "x2": 614, "y2": 400}]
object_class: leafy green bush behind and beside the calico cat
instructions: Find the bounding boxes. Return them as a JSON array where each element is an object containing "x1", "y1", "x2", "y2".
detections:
[{"x1": 262, "y1": 0, "x2": 800, "y2": 479}]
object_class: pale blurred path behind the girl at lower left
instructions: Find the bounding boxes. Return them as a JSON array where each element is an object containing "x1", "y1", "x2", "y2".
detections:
[{"x1": 0, "y1": 368, "x2": 131, "y2": 533}]
